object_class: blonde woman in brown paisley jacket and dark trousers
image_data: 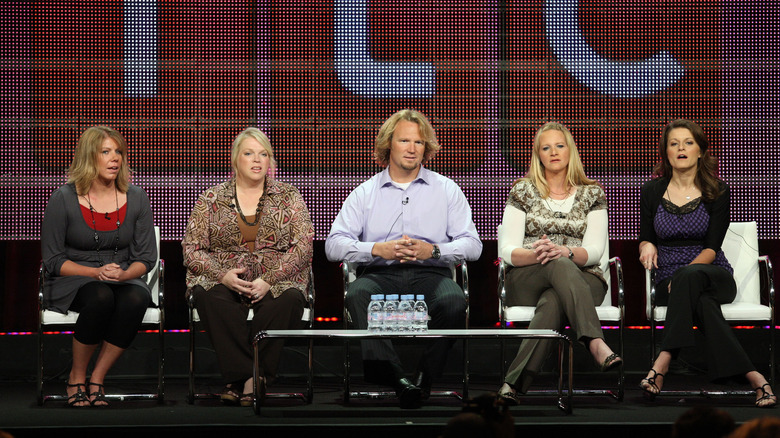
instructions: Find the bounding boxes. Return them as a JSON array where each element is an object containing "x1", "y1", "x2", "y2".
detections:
[{"x1": 182, "y1": 128, "x2": 314, "y2": 406}]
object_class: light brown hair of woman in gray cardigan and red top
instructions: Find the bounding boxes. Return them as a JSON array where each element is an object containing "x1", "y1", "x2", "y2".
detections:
[{"x1": 68, "y1": 125, "x2": 131, "y2": 195}]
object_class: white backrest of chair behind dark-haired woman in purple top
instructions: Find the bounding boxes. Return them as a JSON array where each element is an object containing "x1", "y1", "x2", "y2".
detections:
[{"x1": 721, "y1": 222, "x2": 761, "y2": 304}]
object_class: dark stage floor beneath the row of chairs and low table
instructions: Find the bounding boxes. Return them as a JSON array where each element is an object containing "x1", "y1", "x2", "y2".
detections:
[{"x1": 0, "y1": 373, "x2": 780, "y2": 438}]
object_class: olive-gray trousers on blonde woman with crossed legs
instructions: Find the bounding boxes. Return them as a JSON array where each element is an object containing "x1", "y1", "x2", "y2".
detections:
[{"x1": 504, "y1": 258, "x2": 607, "y2": 393}]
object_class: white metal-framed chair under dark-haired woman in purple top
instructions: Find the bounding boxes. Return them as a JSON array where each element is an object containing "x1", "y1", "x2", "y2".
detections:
[{"x1": 645, "y1": 222, "x2": 775, "y2": 395}]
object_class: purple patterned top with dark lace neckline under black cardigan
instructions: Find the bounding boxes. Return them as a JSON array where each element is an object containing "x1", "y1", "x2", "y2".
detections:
[{"x1": 653, "y1": 198, "x2": 734, "y2": 284}]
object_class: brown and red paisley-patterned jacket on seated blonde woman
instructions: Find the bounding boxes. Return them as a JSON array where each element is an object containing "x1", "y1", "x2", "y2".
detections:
[{"x1": 182, "y1": 177, "x2": 314, "y2": 298}]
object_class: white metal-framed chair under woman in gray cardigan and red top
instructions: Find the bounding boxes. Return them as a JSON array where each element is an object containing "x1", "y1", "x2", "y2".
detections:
[{"x1": 38, "y1": 227, "x2": 165, "y2": 405}]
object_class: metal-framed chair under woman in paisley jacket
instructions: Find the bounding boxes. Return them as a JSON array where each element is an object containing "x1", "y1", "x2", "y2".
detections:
[{"x1": 187, "y1": 266, "x2": 315, "y2": 404}]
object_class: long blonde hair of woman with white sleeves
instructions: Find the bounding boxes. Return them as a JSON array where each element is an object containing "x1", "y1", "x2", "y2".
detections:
[{"x1": 512, "y1": 122, "x2": 598, "y2": 198}]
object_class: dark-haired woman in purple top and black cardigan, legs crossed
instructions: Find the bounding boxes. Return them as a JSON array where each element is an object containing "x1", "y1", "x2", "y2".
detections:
[{"x1": 639, "y1": 120, "x2": 777, "y2": 407}]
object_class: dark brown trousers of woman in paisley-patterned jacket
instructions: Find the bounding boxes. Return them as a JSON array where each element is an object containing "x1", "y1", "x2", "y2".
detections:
[{"x1": 192, "y1": 284, "x2": 306, "y2": 383}]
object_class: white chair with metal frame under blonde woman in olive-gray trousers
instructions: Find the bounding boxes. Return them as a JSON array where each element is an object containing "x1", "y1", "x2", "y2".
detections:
[{"x1": 498, "y1": 225, "x2": 625, "y2": 401}]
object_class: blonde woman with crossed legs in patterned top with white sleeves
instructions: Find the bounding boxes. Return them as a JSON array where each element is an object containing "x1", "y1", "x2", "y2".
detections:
[{"x1": 498, "y1": 122, "x2": 622, "y2": 403}]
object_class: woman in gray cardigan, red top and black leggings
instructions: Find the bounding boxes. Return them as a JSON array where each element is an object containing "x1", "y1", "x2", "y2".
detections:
[{"x1": 41, "y1": 126, "x2": 157, "y2": 407}]
